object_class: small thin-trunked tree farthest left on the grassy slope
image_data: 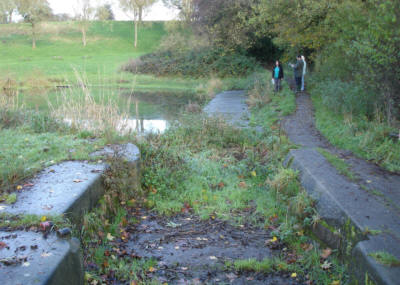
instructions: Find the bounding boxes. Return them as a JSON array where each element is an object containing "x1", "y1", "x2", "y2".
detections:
[{"x1": 16, "y1": 0, "x2": 51, "y2": 49}]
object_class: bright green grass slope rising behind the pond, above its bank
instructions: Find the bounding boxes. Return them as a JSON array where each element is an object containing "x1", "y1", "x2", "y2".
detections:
[{"x1": 0, "y1": 22, "x2": 165, "y2": 80}]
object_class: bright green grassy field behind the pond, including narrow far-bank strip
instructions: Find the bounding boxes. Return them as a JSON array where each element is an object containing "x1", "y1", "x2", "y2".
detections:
[{"x1": 0, "y1": 22, "x2": 199, "y2": 91}]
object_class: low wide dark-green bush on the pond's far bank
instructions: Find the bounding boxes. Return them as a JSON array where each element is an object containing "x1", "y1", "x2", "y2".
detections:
[{"x1": 121, "y1": 48, "x2": 258, "y2": 78}]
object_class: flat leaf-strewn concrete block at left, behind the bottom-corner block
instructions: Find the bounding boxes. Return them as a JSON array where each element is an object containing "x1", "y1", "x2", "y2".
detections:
[{"x1": 1, "y1": 161, "x2": 105, "y2": 221}]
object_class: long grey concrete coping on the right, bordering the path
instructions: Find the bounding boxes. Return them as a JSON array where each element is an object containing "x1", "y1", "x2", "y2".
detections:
[{"x1": 285, "y1": 148, "x2": 400, "y2": 285}]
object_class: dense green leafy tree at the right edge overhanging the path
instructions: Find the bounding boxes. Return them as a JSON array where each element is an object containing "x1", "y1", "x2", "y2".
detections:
[{"x1": 324, "y1": 0, "x2": 400, "y2": 124}]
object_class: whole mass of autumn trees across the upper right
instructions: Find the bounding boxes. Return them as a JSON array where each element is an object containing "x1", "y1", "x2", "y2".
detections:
[{"x1": 163, "y1": 0, "x2": 400, "y2": 124}]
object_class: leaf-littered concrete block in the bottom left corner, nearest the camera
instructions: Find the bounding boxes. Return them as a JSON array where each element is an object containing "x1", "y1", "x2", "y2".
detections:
[{"x1": 0, "y1": 231, "x2": 84, "y2": 285}]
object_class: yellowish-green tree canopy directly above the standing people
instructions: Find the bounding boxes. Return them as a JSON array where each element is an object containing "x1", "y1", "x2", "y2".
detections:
[{"x1": 250, "y1": 0, "x2": 342, "y2": 59}]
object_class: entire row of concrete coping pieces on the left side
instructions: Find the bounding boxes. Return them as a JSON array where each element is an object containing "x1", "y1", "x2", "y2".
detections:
[{"x1": 0, "y1": 143, "x2": 140, "y2": 285}]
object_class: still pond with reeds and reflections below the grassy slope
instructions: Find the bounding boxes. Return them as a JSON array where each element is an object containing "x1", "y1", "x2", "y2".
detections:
[{"x1": 20, "y1": 87, "x2": 198, "y2": 133}]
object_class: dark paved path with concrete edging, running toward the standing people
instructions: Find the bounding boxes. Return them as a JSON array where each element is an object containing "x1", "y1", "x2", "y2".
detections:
[{"x1": 283, "y1": 90, "x2": 400, "y2": 285}]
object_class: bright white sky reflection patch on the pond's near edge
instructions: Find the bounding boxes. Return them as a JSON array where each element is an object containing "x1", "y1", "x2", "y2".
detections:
[{"x1": 118, "y1": 119, "x2": 168, "y2": 134}]
